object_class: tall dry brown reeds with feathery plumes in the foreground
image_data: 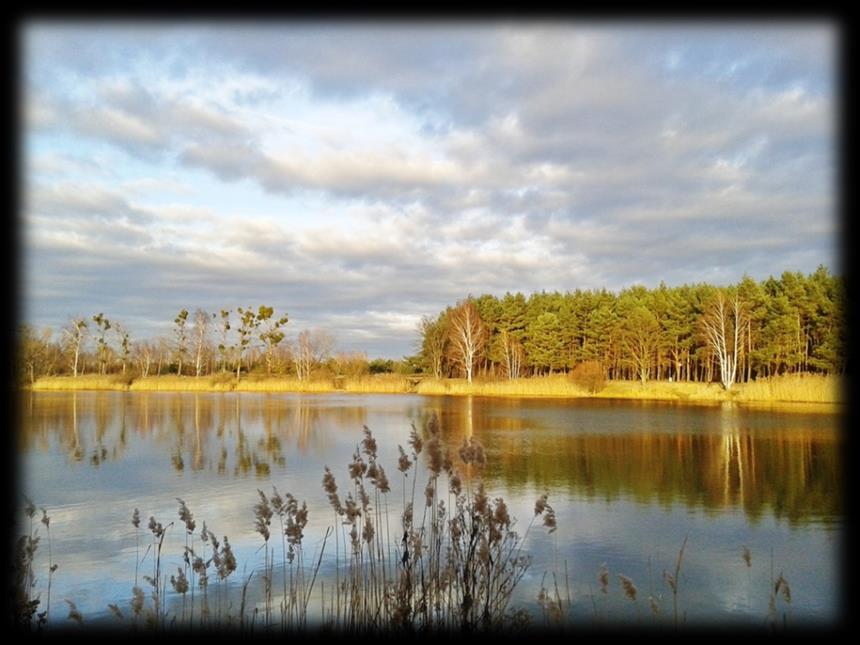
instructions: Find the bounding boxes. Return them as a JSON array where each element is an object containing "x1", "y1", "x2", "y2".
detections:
[{"x1": 12, "y1": 428, "x2": 792, "y2": 636}]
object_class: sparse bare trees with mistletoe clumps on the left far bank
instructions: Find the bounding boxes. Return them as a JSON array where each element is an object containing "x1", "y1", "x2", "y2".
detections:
[{"x1": 18, "y1": 305, "x2": 371, "y2": 383}]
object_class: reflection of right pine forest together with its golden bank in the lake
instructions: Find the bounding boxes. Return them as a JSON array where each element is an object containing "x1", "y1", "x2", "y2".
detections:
[{"x1": 404, "y1": 397, "x2": 843, "y2": 524}]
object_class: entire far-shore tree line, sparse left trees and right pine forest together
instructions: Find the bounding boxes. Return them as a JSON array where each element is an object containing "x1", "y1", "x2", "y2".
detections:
[{"x1": 18, "y1": 266, "x2": 846, "y2": 389}]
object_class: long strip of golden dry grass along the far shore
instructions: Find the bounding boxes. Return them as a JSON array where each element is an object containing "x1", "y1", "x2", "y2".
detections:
[{"x1": 31, "y1": 374, "x2": 844, "y2": 403}]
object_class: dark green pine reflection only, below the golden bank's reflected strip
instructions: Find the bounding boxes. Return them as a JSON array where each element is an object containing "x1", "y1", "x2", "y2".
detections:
[{"x1": 478, "y1": 422, "x2": 842, "y2": 523}]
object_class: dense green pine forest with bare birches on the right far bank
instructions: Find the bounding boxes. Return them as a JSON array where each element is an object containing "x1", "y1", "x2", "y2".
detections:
[{"x1": 419, "y1": 266, "x2": 846, "y2": 389}]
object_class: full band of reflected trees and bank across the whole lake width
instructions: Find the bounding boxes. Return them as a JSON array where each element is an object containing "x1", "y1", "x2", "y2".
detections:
[{"x1": 19, "y1": 392, "x2": 843, "y2": 524}]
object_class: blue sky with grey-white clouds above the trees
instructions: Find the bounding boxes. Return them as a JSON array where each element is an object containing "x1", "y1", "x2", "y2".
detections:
[{"x1": 19, "y1": 19, "x2": 840, "y2": 358}]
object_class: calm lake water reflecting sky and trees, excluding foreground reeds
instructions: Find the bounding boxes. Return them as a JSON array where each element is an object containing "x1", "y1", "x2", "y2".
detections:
[{"x1": 19, "y1": 392, "x2": 844, "y2": 626}]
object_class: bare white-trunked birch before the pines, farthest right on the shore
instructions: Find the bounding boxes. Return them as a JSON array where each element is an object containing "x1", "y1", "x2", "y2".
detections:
[{"x1": 701, "y1": 290, "x2": 748, "y2": 390}]
